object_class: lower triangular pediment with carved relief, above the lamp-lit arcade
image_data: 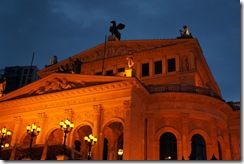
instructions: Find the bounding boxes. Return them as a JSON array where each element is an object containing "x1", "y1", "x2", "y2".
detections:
[{"x1": 0, "y1": 73, "x2": 133, "y2": 101}]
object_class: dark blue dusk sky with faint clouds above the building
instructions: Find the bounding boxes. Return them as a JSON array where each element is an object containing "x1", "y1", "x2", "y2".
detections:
[{"x1": 0, "y1": 0, "x2": 241, "y2": 101}]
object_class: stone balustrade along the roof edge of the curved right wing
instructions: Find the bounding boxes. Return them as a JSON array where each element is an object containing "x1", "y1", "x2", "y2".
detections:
[{"x1": 146, "y1": 84, "x2": 224, "y2": 101}]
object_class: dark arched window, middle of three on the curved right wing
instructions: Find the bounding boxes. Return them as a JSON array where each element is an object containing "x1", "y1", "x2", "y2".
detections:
[{"x1": 190, "y1": 134, "x2": 207, "y2": 160}]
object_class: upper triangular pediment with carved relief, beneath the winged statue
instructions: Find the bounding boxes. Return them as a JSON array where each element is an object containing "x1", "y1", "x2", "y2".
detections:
[{"x1": 37, "y1": 39, "x2": 195, "y2": 78}]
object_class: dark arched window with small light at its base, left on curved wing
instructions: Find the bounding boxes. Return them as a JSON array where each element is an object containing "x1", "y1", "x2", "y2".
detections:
[{"x1": 160, "y1": 132, "x2": 177, "y2": 160}]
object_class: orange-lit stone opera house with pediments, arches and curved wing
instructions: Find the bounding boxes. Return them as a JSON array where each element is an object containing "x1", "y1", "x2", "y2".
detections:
[{"x1": 0, "y1": 27, "x2": 241, "y2": 160}]
